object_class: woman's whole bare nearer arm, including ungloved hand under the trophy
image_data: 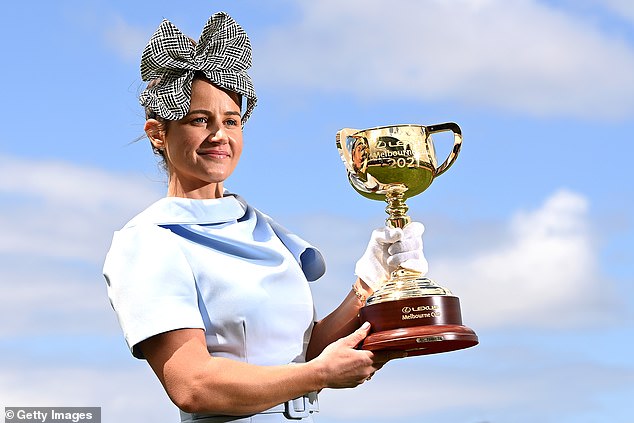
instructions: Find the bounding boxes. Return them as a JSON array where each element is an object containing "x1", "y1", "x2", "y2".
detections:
[{"x1": 139, "y1": 326, "x2": 386, "y2": 415}]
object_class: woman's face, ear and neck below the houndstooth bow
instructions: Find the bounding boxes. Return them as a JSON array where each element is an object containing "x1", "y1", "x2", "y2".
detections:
[{"x1": 146, "y1": 79, "x2": 242, "y2": 198}]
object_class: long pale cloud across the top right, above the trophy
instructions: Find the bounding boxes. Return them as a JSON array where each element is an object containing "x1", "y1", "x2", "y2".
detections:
[{"x1": 254, "y1": 0, "x2": 634, "y2": 118}]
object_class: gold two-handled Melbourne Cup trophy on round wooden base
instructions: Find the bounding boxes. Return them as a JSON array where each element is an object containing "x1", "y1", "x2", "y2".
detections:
[{"x1": 337, "y1": 122, "x2": 478, "y2": 356}]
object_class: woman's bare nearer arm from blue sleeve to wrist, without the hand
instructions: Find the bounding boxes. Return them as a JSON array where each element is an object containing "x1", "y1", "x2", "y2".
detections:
[{"x1": 141, "y1": 329, "x2": 327, "y2": 415}]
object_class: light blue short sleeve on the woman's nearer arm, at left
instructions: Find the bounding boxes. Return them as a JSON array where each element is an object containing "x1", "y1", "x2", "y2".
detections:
[{"x1": 103, "y1": 224, "x2": 204, "y2": 358}]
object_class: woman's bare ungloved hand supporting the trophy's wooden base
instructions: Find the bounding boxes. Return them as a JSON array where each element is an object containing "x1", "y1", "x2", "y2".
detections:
[{"x1": 312, "y1": 322, "x2": 407, "y2": 388}]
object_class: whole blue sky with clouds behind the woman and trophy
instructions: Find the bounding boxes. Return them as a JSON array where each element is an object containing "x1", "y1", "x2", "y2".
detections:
[{"x1": 0, "y1": 0, "x2": 634, "y2": 423}]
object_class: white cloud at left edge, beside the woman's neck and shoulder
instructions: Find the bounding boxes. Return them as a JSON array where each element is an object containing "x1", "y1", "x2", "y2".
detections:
[{"x1": 0, "y1": 156, "x2": 160, "y2": 263}]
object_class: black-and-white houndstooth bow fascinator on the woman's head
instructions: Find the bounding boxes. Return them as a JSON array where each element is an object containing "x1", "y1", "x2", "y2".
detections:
[{"x1": 139, "y1": 12, "x2": 257, "y2": 124}]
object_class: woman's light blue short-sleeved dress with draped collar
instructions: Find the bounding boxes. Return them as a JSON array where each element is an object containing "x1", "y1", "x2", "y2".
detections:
[{"x1": 103, "y1": 194, "x2": 325, "y2": 423}]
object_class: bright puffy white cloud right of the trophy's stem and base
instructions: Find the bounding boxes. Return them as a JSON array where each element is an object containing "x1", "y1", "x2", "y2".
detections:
[{"x1": 431, "y1": 191, "x2": 618, "y2": 328}]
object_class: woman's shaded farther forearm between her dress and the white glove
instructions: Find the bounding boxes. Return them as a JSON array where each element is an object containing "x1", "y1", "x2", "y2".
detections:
[{"x1": 306, "y1": 278, "x2": 373, "y2": 361}]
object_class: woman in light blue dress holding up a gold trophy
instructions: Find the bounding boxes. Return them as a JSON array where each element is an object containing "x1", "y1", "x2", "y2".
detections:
[{"x1": 104, "y1": 13, "x2": 426, "y2": 423}]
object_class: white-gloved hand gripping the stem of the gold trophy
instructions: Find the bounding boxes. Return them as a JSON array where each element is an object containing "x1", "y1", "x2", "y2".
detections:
[{"x1": 355, "y1": 222, "x2": 427, "y2": 291}]
